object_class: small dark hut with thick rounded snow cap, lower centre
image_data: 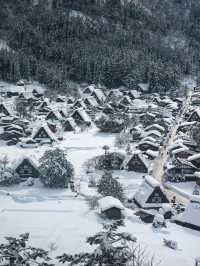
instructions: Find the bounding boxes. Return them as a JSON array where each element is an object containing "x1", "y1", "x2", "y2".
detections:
[{"x1": 98, "y1": 196, "x2": 125, "y2": 220}]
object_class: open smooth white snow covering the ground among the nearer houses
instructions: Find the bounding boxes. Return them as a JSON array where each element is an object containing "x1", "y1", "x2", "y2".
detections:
[{"x1": 0, "y1": 128, "x2": 200, "y2": 266}]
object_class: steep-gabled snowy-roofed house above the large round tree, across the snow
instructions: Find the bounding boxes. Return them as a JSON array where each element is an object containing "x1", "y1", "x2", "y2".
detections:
[{"x1": 32, "y1": 125, "x2": 56, "y2": 143}]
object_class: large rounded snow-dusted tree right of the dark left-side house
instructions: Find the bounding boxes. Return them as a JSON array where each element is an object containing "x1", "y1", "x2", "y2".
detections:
[{"x1": 39, "y1": 148, "x2": 74, "y2": 188}]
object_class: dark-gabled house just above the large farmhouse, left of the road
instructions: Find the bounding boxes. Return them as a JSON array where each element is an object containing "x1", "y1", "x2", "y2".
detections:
[{"x1": 123, "y1": 151, "x2": 149, "y2": 173}]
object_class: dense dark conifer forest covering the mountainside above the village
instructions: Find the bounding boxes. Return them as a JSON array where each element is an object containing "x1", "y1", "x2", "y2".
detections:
[{"x1": 0, "y1": 0, "x2": 200, "y2": 92}]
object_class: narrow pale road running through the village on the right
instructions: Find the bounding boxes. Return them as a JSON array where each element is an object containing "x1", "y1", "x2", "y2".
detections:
[{"x1": 153, "y1": 90, "x2": 192, "y2": 204}]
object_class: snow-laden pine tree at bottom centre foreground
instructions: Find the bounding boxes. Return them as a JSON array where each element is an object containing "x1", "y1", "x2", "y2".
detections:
[{"x1": 58, "y1": 221, "x2": 137, "y2": 266}]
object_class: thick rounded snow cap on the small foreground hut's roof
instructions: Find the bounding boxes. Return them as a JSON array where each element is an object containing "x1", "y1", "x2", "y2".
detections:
[{"x1": 98, "y1": 196, "x2": 124, "y2": 212}]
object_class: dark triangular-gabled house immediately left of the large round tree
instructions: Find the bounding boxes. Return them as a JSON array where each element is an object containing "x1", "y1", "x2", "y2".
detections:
[{"x1": 14, "y1": 157, "x2": 40, "y2": 179}]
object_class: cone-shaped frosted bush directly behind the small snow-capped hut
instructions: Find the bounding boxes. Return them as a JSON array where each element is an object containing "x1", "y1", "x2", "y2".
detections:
[{"x1": 98, "y1": 172, "x2": 124, "y2": 202}]
